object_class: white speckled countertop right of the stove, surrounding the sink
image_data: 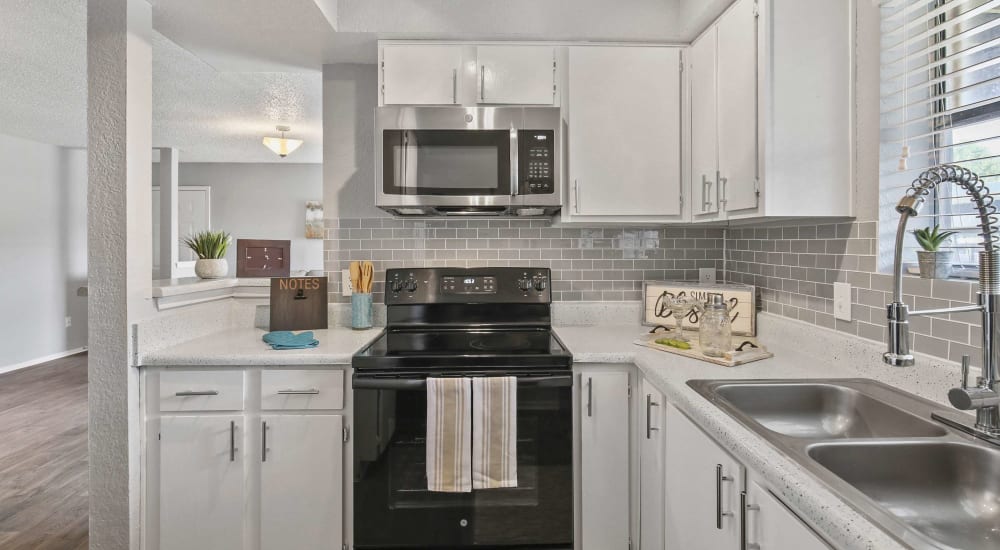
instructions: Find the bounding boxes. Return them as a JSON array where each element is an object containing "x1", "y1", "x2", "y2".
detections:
[{"x1": 557, "y1": 314, "x2": 959, "y2": 550}]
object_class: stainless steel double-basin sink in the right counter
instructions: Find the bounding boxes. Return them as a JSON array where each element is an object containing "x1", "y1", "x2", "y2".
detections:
[{"x1": 688, "y1": 379, "x2": 1000, "y2": 550}]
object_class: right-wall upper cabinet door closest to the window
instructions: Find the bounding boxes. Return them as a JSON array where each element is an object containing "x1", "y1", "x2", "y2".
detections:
[{"x1": 718, "y1": 0, "x2": 758, "y2": 216}]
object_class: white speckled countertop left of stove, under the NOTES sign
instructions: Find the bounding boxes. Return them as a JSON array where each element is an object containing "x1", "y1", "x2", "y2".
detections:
[{"x1": 139, "y1": 327, "x2": 382, "y2": 367}]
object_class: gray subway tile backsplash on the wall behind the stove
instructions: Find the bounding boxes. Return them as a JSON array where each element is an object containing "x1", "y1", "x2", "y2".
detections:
[{"x1": 325, "y1": 218, "x2": 724, "y2": 302}]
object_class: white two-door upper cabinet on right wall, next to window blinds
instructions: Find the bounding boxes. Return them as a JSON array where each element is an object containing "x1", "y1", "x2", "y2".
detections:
[{"x1": 688, "y1": 0, "x2": 854, "y2": 221}]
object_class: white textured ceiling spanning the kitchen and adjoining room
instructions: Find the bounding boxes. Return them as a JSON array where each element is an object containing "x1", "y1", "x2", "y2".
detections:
[{"x1": 0, "y1": 0, "x2": 732, "y2": 162}]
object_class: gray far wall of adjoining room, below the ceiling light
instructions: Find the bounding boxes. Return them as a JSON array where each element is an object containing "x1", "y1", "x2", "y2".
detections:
[{"x1": 153, "y1": 163, "x2": 329, "y2": 276}]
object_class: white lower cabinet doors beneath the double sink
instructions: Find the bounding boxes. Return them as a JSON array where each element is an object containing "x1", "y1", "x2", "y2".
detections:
[{"x1": 664, "y1": 406, "x2": 829, "y2": 550}]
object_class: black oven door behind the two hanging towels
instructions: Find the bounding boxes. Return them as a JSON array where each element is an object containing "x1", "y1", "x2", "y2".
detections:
[{"x1": 354, "y1": 386, "x2": 573, "y2": 549}]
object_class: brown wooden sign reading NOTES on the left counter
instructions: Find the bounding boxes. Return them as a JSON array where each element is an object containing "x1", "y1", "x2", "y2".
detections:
[{"x1": 270, "y1": 277, "x2": 328, "y2": 330}]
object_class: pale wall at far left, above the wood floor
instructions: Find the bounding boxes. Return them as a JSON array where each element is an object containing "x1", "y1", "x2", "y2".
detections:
[{"x1": 0, "y1": 135, "x2": 87, "y2": 371}]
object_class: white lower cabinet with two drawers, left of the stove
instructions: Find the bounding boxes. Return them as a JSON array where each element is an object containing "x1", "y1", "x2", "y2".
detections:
[{"x1": 141, "y1": 368, "x2": 347, "y2": 550}]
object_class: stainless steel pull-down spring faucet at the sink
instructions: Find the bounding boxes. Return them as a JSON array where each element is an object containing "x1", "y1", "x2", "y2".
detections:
[{"x1": 882, "y1": 164, "x2": 1000, "y2": 438}]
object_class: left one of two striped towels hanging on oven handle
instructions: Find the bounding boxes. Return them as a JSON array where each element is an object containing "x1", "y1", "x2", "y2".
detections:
[{"x1": 427, "y1": 378, "x2": 472, "y2": 493}]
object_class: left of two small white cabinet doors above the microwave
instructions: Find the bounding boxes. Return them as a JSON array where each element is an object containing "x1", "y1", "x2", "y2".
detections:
[{"x1": 382, "y1": 45, "x2": 462, "y2": 105}]
